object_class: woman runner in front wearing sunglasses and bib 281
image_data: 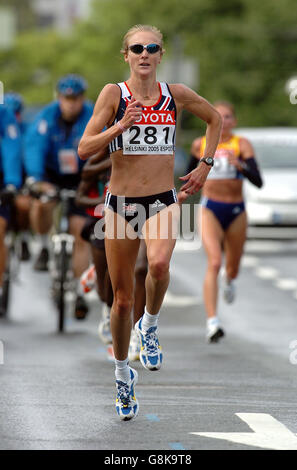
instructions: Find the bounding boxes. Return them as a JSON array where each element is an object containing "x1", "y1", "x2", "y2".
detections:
[{"x1": 79, "y1": 25, "x2": 221, "y2": 420}]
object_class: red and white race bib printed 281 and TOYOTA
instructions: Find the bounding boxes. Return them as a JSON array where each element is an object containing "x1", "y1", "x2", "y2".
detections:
[{"x1": 122, "y1": 109, "x2": 175, "y2": 155}]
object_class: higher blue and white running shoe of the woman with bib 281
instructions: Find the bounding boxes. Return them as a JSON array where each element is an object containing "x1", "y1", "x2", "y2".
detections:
[{"x1": 134, "y1": 317, "x2": 163, "y2": 370}]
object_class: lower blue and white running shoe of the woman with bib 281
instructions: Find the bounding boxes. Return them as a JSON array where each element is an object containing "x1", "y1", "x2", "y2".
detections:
[{"x1": 116, "y1": 367, "x2": 139, "y2": 421}]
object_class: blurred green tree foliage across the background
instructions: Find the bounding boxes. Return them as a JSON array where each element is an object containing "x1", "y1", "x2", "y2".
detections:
[{"x1": 0, "y1": 0, "x2": 297, "y2": 129}]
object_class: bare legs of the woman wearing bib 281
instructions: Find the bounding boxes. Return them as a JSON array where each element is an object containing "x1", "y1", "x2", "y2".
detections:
[{"x1": 105, "y1": 204, "x2": 179, "y2": 360}]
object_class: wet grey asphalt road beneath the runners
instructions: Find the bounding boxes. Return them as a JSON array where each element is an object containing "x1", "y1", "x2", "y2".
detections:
[{"x1": 0, "y1": 241, "x2": 297, "y2": 450}]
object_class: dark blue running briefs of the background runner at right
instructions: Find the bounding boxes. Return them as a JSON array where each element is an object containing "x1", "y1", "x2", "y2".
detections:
[{"x1": 200, "y1": 196, "x2": 245, "y2": 232}]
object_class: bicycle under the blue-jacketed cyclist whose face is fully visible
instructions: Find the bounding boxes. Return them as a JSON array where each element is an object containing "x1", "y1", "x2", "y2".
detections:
[{"x1": 30, "y1": 183, "x2": 76, "y2": 333}]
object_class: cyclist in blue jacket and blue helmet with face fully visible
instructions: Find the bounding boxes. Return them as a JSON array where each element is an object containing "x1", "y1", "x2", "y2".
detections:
[{"x1": 25, "y1": 74, "x2": 93, "y2": 319}]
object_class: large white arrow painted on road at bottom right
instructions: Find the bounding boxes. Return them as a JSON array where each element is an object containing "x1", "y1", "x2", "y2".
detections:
[{"x1": 190, "y1": 413, "x2": 297, "y2": 450}]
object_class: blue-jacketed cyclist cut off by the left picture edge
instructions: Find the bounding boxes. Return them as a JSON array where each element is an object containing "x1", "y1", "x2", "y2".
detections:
[{"x1": 0, "y1": 105, "x2": 22, "y2": 315}]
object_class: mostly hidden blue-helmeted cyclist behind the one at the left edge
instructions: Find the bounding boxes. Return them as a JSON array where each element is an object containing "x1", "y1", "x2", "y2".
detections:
[{"x1": 4, "y1": 91, "x2": 31, "y2": 261}]
